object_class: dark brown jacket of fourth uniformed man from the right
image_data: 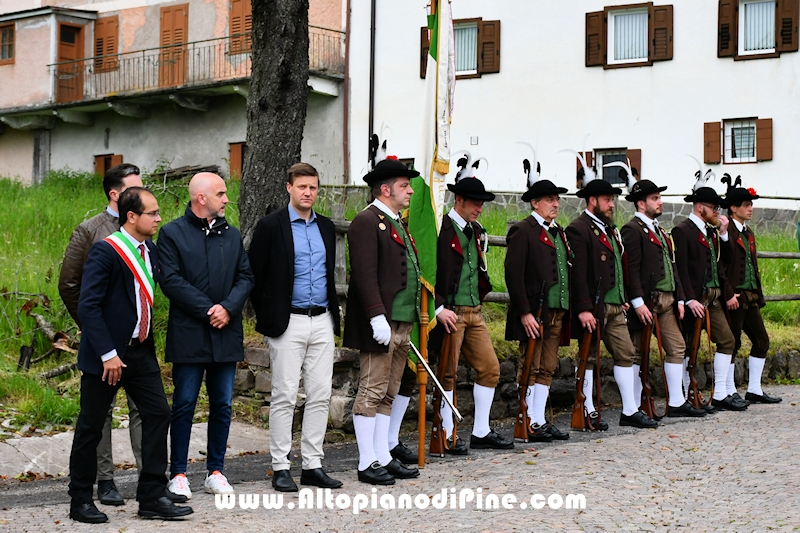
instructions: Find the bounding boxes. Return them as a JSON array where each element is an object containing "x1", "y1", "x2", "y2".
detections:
[{"x1": 567, "y1": 212, "x2": 627, "y2": 335}]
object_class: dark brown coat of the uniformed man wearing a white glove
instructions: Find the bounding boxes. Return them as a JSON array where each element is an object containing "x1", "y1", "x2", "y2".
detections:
[{"x1": 342, "y1": 206, "x2": 416, "y2": 353}]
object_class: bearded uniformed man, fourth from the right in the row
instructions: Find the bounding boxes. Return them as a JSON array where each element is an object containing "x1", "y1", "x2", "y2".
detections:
[{"x1": 567, "y1": 179, "x2": 658, "y2": 430}]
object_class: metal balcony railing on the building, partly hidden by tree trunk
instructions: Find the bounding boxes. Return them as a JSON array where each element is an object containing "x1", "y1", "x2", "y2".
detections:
[{"x1": 48, "y1": 26, "x2": 344, "y2": 103}]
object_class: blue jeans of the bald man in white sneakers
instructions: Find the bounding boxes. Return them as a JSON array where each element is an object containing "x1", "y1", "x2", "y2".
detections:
[{"x1": 169, "y1": 363, "x2": 236, "y2": 476}]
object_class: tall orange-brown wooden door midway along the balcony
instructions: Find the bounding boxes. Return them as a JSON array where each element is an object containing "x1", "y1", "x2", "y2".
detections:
[{"x1": 158, "y1": 4, "x2": 189, "y2": 87}]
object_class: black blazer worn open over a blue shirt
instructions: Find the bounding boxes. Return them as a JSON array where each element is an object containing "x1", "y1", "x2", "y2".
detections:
[{"x1": 249, "y1": 206, "x2": 340, "y2": 337}]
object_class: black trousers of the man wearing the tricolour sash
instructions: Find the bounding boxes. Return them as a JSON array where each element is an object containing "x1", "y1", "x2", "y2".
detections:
[{"x1": 69, "y1": 342, "x2": 170, "y2": 504}]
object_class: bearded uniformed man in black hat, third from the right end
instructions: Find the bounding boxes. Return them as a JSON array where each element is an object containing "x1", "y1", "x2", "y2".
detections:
[{"x1": 621, "y1": 180, "x2": 706, "y2": 417}]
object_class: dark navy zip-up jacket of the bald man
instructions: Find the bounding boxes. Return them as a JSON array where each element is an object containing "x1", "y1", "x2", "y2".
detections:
[{"x1": 158, "y1": 205, "x2": 253, "y2": 363}]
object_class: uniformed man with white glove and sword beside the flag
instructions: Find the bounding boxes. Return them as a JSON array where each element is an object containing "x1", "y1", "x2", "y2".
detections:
[{"x1": 342, "y1": 159, "x2": 422, "y2": 485}]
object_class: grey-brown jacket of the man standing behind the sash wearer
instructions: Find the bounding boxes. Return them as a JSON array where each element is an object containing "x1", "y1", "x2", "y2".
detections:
[{"x1": 58, "y1": 209, "x2": 119, "y2": 328}]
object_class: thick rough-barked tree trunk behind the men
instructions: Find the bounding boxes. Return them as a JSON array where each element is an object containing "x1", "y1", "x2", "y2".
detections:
[{"x1": 239, "y1": 0, "x2": 308, "y2": 248}]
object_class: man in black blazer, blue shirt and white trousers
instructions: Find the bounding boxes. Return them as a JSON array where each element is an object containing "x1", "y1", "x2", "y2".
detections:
[{"x1": 250, "y1": 163, "x2": 342, "y2": 492}]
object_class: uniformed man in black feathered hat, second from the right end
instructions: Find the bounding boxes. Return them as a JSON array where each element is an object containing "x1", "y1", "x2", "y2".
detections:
[{"x1": 672, "y1": 187, "x2": 747, "y2": 411}]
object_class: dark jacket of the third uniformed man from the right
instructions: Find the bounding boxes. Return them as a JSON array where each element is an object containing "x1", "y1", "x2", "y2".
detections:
[{"x1": 620, "y1": 217, "x2": 684, "y2": 330}]
